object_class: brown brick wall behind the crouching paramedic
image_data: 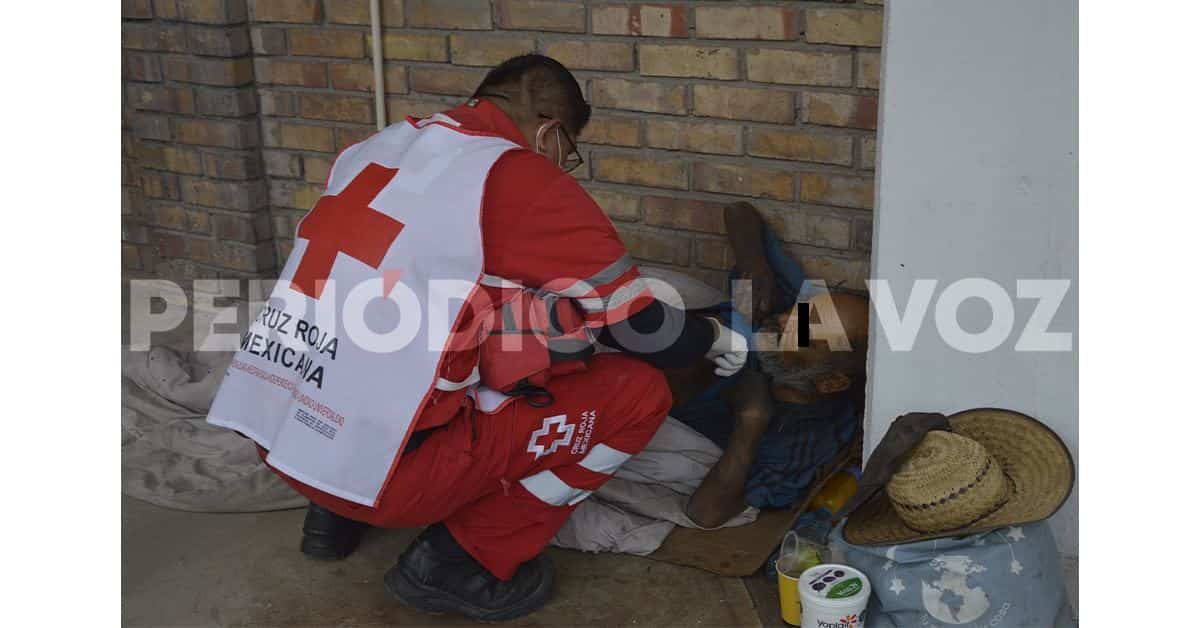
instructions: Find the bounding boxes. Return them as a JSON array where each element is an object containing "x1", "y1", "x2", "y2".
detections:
[{"x1": 122, "y1": 0, "x2": 882, "y2": 292}]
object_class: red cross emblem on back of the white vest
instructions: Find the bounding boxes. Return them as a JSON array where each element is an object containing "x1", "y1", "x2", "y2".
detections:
[{"x1": 292, "y1": 163, "x2": 404, "y2": 299}]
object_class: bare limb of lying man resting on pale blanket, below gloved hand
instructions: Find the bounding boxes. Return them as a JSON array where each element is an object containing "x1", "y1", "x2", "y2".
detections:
[{"x1": 685, "y1": 370, "x2": 773, "y2": 527}]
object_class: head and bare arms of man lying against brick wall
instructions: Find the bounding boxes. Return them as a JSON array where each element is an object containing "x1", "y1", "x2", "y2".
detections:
[{"x1": 665, "y1": 203, "x2": 868, "y2": 527}]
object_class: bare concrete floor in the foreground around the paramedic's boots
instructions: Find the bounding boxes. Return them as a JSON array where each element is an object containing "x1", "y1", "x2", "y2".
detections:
[{"x1": 121, "y1": 497, "x2": 786, "y2": 627}]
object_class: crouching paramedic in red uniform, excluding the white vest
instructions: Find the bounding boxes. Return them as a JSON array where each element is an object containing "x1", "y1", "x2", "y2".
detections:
[{"x1": 271, "y1": 55, "x2": 745, "y2": 621}]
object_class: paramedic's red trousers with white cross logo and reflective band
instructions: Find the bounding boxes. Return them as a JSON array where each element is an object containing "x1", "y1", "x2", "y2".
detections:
[{"x1": 266, "y1": 353, "x2": 671, "y2": 580}]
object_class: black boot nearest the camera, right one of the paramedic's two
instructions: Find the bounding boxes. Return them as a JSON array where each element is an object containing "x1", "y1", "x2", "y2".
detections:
[{"x1": 384, "y1": 524, "x2": 554, "y2": 621}]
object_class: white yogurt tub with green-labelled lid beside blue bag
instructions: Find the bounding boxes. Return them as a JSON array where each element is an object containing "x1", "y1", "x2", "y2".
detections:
[{"x1": 799, "y1": 564, "x2": 871, "y2": 628}]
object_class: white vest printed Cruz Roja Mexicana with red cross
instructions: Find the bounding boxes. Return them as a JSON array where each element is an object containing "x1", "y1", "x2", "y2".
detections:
[{"x1": 208, "y1": 114, "x2": 517, "y2": 506}]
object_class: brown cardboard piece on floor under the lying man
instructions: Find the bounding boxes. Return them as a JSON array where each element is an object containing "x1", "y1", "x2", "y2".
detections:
[{"x1": 647, "y1": 441, "x2": 860, "y2": 576}]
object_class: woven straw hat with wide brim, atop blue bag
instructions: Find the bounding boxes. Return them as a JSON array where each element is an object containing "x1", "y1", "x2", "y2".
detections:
[{"x1": 844, "y1": 408, "x2": 1075, "y2": 545}]
